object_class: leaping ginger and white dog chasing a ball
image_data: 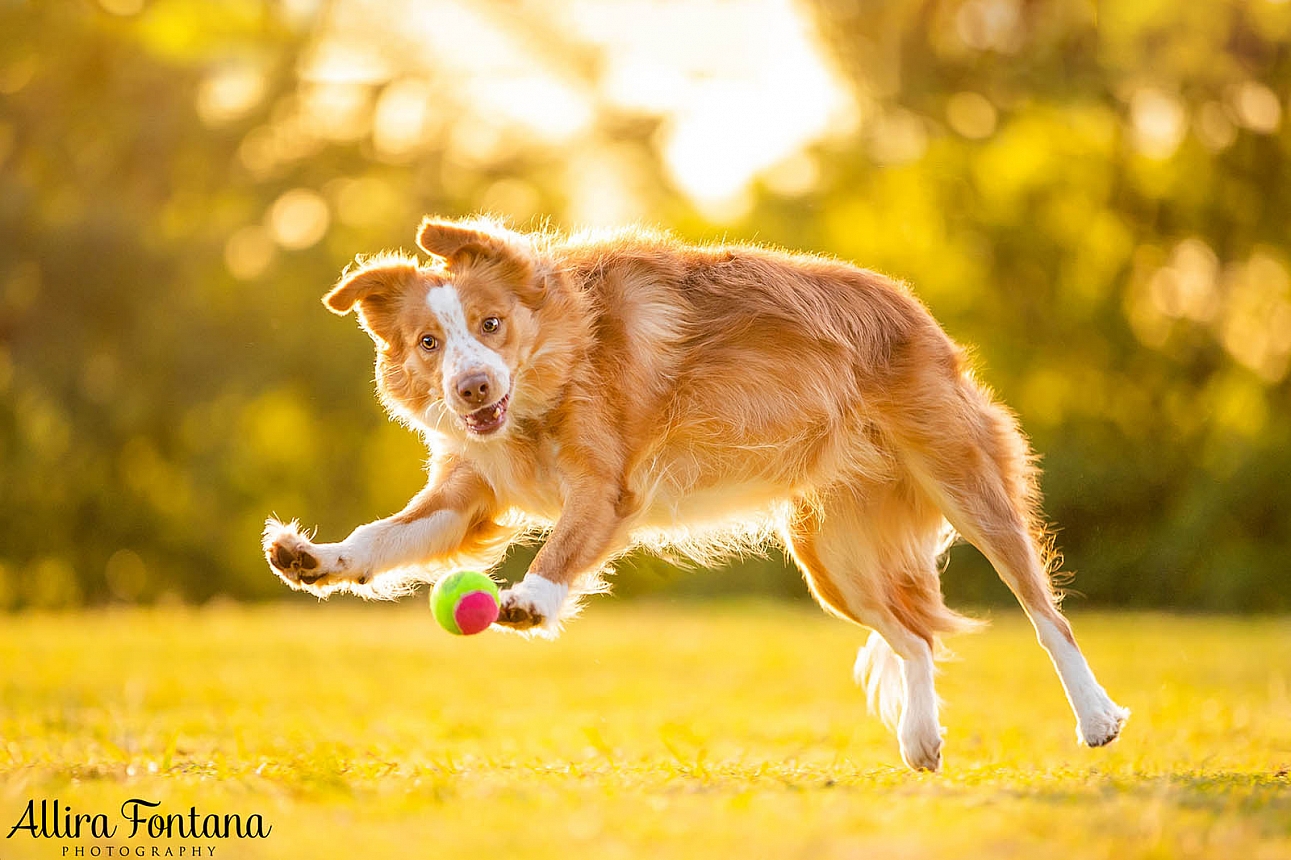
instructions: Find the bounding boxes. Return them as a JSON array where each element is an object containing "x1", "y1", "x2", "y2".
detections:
[{"x1": 263, "y1": 217, "x2": 1128, "y2": 771}]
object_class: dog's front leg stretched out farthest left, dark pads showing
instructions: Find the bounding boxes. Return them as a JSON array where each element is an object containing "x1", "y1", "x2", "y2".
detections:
[{"x1": 263, "y1": 464, "x2": 493, "y2": 597}]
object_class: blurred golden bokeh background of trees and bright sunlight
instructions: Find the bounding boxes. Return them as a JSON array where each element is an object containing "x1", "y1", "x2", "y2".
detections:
[{"x1": 0, "y1": 0, "x2": 1291, "y2": 611}]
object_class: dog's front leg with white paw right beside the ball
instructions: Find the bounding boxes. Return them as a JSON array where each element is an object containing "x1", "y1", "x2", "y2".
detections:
[{"x1": 497, "y1": 482, "x2": 634, "y2": 631}]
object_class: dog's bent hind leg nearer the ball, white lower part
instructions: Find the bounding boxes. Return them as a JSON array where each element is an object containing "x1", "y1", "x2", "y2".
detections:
[{"x1": 784, "y1": 480, "x2": 975, "y2": 771}]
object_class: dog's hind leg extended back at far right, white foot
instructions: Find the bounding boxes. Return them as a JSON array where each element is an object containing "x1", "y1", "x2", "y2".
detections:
[{"x1": 897, "y1": 377, "x2": 1130, "y2": 746}]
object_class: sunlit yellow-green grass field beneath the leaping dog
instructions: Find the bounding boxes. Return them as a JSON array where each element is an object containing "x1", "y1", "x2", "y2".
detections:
[{"x1": 0, "y1": 599, "x2": 1291, "y2": 860}]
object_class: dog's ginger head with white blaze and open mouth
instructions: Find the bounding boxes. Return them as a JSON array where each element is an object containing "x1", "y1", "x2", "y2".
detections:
[{"x1": 324, "y1": 218, "x2": 567, "y2": 440}]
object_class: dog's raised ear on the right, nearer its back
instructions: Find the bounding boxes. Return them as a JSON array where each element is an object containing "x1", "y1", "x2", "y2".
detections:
[{"x1": 417, "y1": 216, "x2": 547, "y2": 309}]
